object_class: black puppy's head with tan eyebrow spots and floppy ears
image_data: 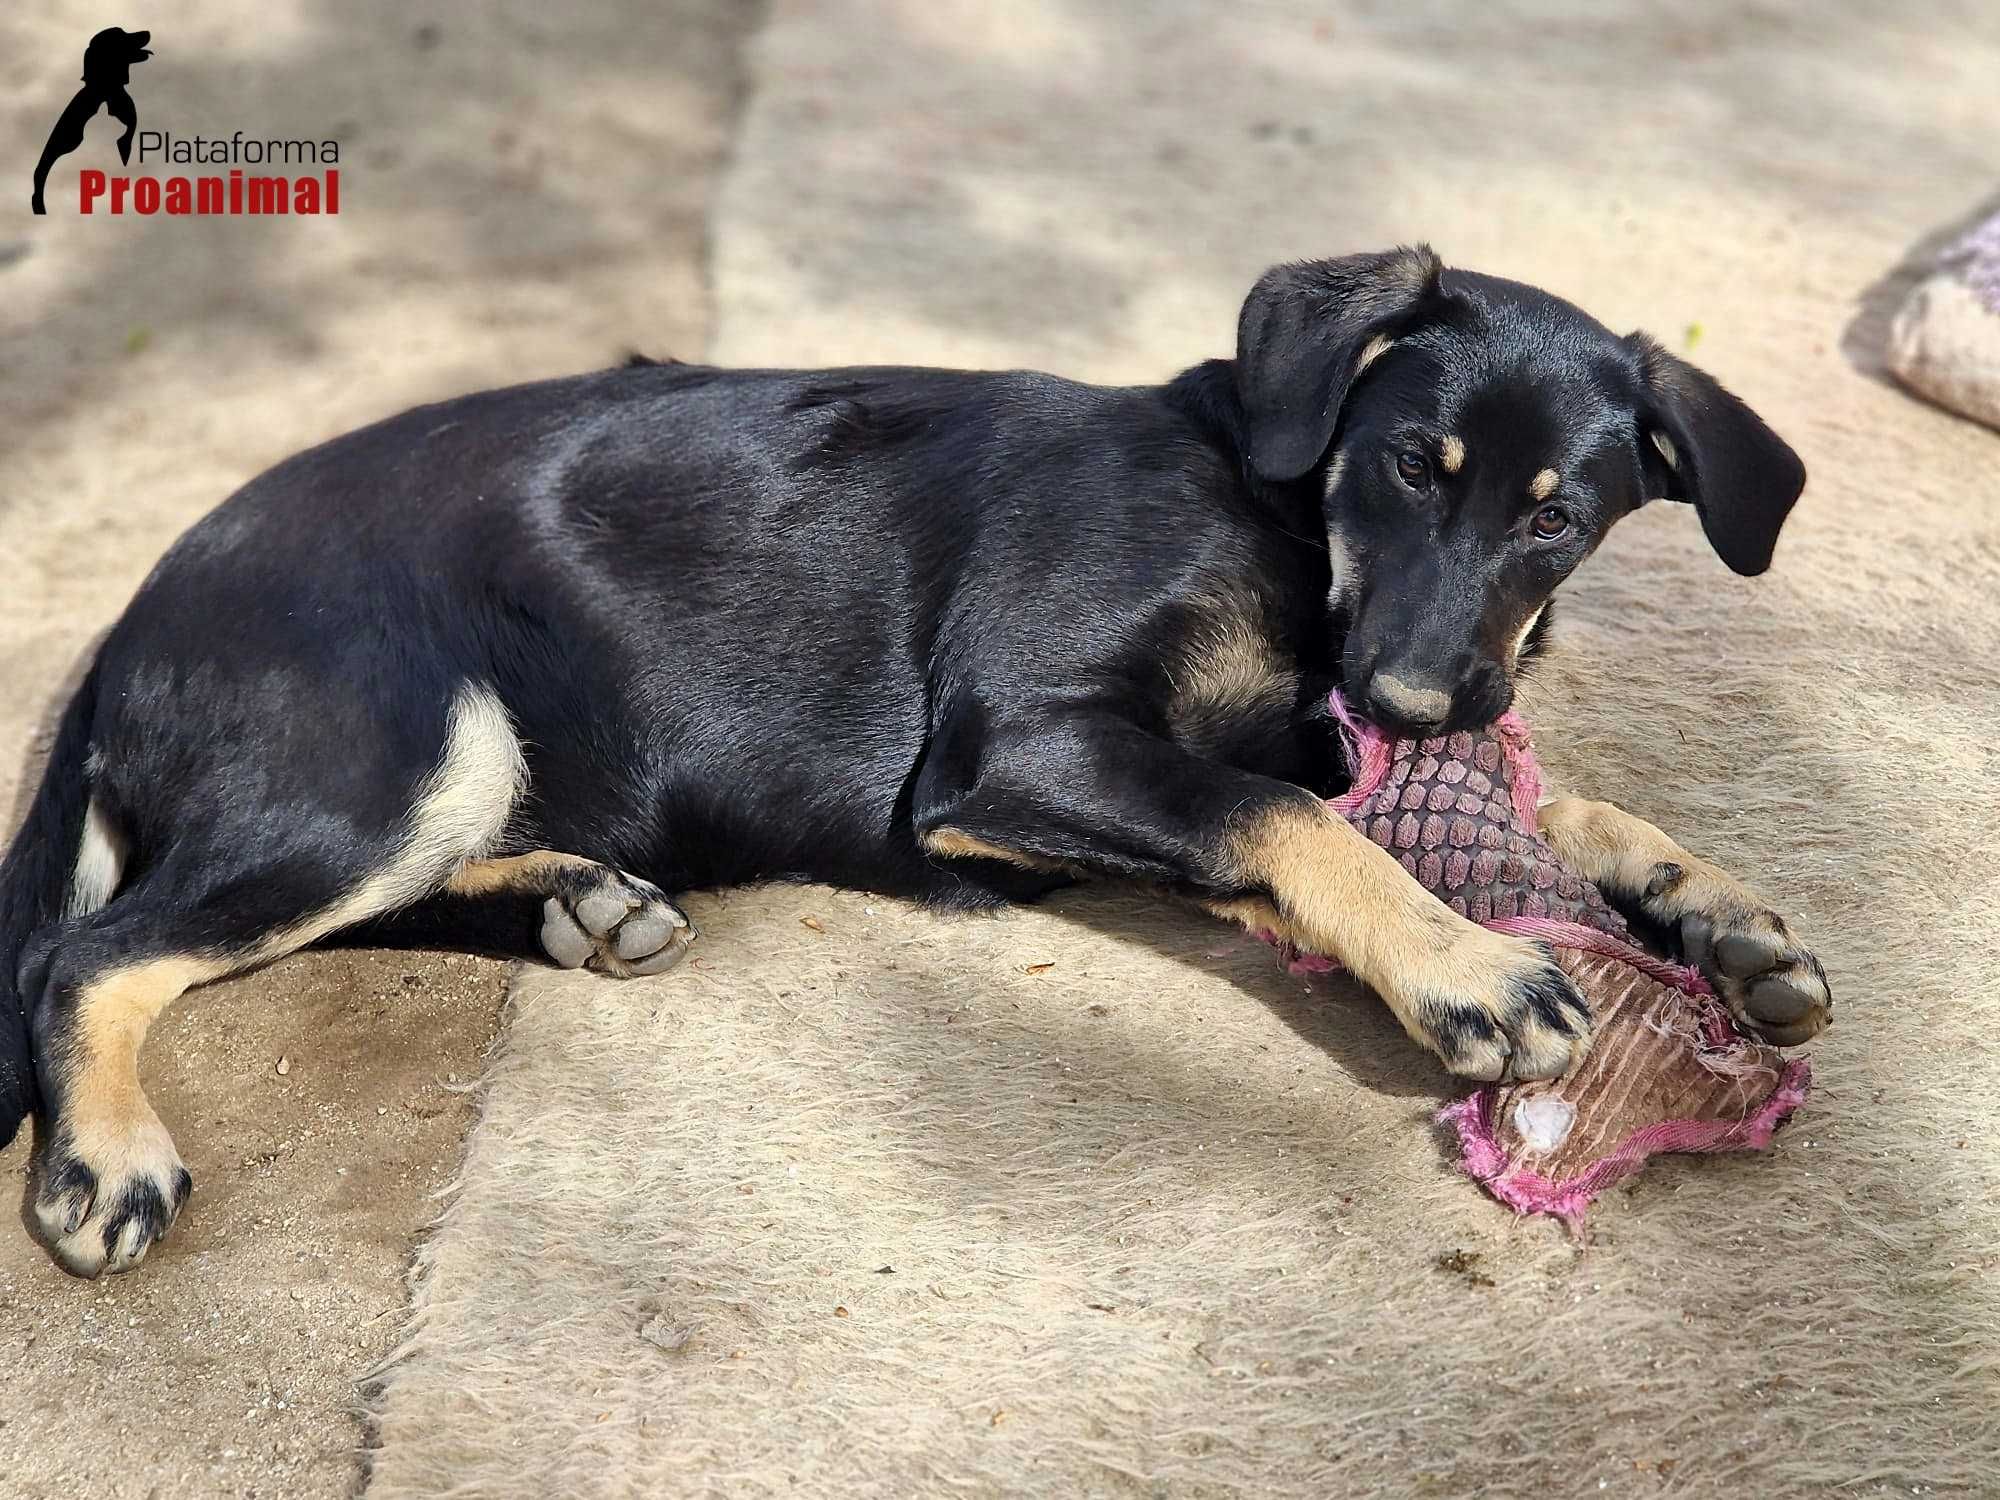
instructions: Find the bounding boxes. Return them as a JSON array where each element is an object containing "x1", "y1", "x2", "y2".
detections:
[{"x1": 1236, "y1": 246, "x2": 1806, "y2": 732}]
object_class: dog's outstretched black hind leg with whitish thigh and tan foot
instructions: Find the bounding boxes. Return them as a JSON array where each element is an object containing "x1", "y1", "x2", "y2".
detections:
[{"x1": 20, "y1": 684, "x2": 526, "y2": 1276}]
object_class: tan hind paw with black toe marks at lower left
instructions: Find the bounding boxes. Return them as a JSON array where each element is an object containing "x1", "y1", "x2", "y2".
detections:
[{"x1": 34, "y1": 1110, "x2": 194, "y2": 1278}]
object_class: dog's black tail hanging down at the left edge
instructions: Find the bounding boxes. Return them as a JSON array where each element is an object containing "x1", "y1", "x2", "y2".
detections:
[{"x1": 0, "y1": 666, "x2": 98, "y2": 1148}]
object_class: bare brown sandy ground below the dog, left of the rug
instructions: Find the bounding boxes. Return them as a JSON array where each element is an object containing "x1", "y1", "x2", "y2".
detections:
[{"x1": 0, "y1": 954, "x2": 504, "y2": 1496}]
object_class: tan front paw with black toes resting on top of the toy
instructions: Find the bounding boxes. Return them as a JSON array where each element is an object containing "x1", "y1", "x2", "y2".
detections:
[{"x1": 1394, "y1": 924, "x2": 1590, "y2": 1082}]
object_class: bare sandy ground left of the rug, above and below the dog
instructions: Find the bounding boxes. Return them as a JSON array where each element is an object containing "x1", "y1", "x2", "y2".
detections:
[{"x1": 0, "y1": 0, "x2": 754, "y2": 1496}]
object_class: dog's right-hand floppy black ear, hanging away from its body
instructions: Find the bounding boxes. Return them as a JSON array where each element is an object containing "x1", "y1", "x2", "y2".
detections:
[{"x1": 1626, "y1": 334, "x2": 1806, "y2": 576}]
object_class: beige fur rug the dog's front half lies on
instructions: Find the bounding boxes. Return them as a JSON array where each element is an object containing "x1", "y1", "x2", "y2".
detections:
[{"x1": 374, "y1": 0, "x2": 2000, "y2": 1496}]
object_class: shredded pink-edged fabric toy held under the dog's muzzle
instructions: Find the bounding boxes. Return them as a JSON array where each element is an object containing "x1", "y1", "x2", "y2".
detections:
[{"x1": 1290, "y1": 696, "x2": 1812, "y2": 1230}]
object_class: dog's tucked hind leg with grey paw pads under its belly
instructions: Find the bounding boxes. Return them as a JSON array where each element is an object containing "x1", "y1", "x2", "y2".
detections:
[{"x1": 346, "y1": 850, "x2": 696, "y2": 978}]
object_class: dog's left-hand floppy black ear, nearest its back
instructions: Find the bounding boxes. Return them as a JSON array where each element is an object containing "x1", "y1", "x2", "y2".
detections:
[{"x1": 1236, "y1": 244, "x2": 1444, "y2": 482}]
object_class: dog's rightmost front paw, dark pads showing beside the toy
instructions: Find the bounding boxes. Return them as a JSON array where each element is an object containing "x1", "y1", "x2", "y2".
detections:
[{"x1": 1640, "y1": 862, "x2": 1834, "y2": 1046}]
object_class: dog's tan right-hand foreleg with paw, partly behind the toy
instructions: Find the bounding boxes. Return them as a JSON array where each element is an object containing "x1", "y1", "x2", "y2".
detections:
[{"x1": 1540, "y1": 798, "x2": 1834, "y2": 1046}]
